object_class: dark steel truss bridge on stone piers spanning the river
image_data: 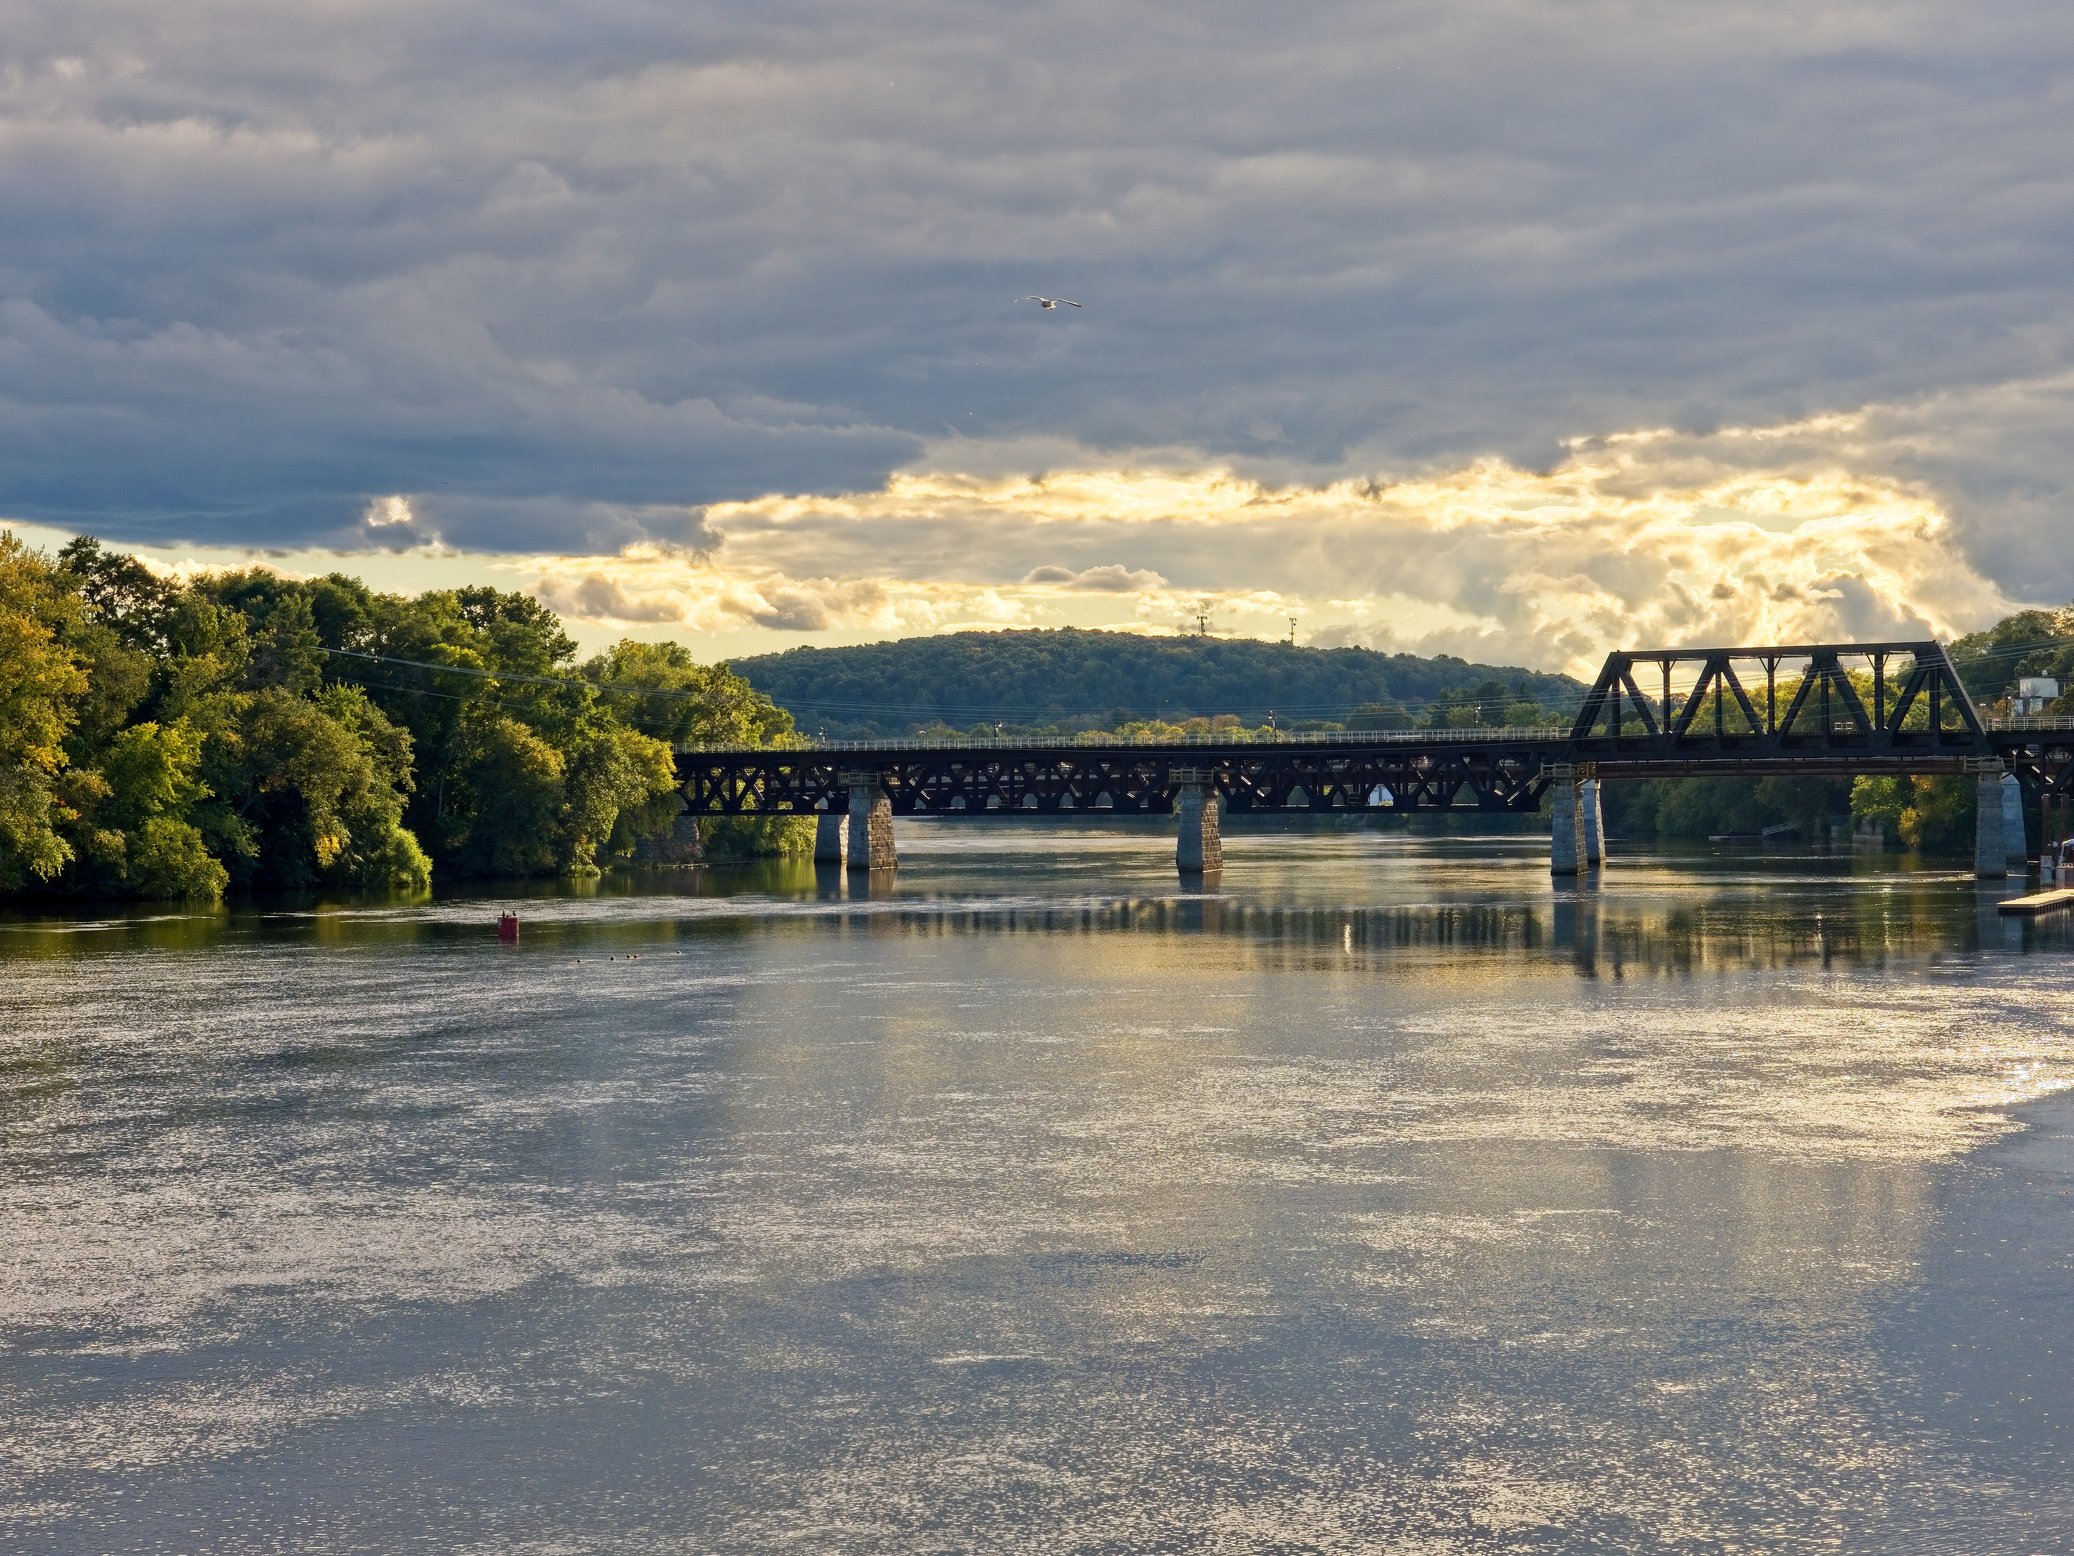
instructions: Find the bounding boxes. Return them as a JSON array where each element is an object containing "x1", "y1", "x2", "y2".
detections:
[{"x1": 678, "y1": 643, "x2": 2074, "y2": 876}]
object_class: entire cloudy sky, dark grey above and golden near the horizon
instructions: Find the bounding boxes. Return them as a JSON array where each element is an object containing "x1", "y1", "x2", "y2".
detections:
[{"x1": 0, "y1": 0, "x2": 2074, "y2": 666}]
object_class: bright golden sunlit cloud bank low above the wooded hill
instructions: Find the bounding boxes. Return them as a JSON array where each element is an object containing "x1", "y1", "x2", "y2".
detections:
[{"x1": 506, "y1": 415, "x2": 2010, "y2": 670}]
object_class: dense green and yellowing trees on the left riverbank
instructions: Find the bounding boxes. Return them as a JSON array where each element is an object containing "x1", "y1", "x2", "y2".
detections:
[{"x1": 0, "y1": 531, "x2": 811, "y2": 896}]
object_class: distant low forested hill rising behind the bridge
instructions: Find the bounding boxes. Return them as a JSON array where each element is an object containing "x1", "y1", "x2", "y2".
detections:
[{"x1": 734, "y1": 629, "x2": 1585, "y2": 737}]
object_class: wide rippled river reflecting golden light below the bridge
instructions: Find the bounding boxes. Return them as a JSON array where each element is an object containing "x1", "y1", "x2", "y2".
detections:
[{"x1": 0, "y1": 822, "x2": 2074, "y2": 1556}]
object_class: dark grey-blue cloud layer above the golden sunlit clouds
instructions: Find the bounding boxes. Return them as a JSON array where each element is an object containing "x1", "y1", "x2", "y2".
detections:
[{"x1": 0, "y1": 0, "x2": 2074, "y2": 598}]
